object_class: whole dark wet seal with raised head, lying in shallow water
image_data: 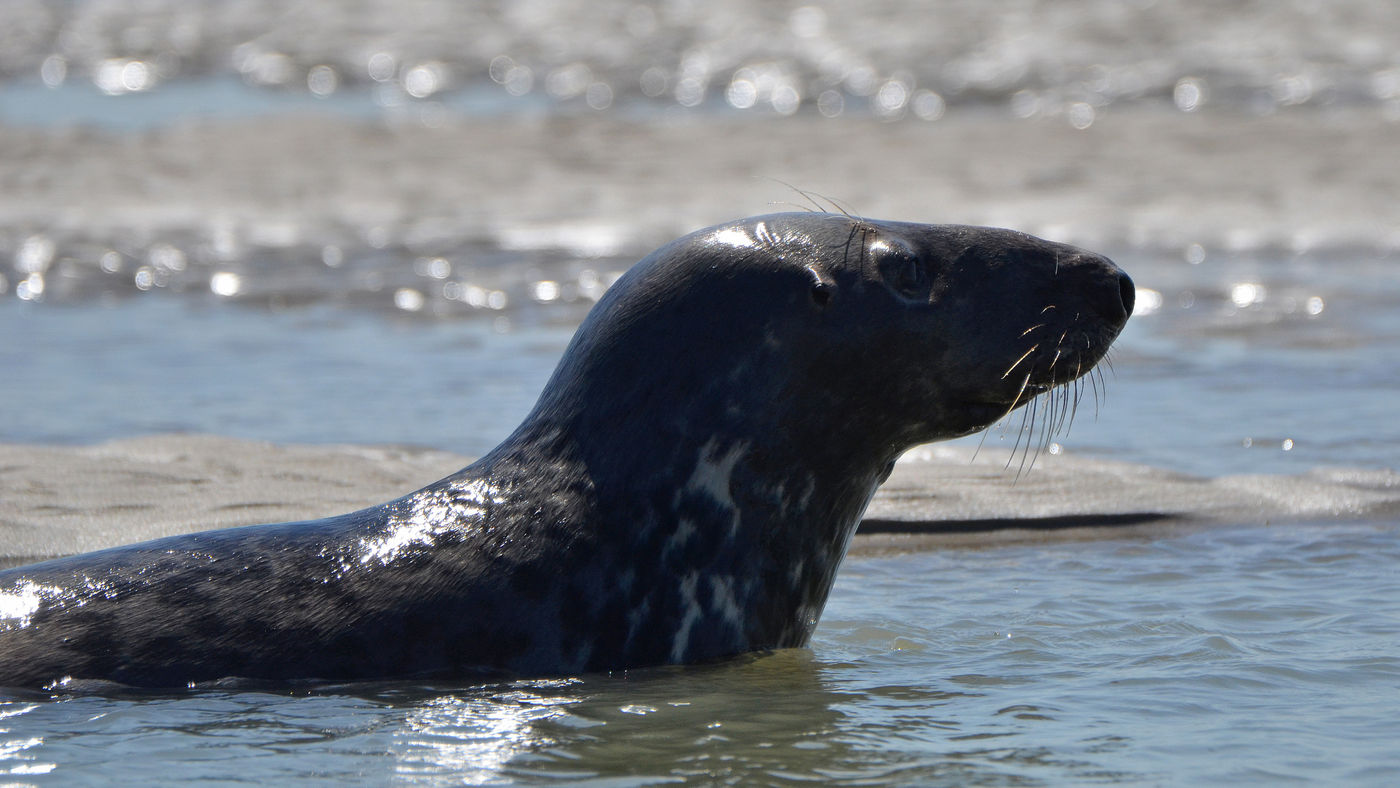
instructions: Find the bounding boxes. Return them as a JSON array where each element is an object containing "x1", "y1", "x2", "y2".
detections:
[{"x1": 0, "y1": 214, "x2": 1133, "y2": 687}]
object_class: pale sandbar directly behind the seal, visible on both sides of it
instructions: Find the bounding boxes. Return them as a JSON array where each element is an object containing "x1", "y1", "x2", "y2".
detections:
[{"x1": 0, "y1": 434, "x2": 1400, "y2": 567}]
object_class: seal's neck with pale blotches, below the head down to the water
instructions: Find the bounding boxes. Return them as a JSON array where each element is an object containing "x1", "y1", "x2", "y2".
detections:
[{"x1": 469, "y1": 372, "x2": 893, "y2": 663}]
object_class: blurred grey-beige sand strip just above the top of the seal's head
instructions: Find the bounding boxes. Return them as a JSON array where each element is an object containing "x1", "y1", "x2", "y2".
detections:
[{"x1": 0, "y1": 108, "x2": 1400, "y2": 255}]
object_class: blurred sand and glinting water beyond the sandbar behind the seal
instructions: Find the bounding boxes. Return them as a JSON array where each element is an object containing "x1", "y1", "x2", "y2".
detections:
[{"x1": 0, "y1": 0, "x2": 1400, "y2": 474}]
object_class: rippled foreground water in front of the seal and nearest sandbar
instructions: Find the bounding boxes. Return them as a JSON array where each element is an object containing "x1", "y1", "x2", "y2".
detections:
[{"x1": 0, "y1": 525, "x2": 1400, "y2": 785}]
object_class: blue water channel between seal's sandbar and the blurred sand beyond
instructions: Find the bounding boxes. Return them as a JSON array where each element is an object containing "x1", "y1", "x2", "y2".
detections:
[{"x1": 0, "y1": 237, "x2": 1400, "y2": 476}]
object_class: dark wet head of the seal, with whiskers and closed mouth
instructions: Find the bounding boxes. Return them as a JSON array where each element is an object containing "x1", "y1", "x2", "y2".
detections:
[{"x1": 529, "y1": 213, "x2": 1133, "y2": 460}]
